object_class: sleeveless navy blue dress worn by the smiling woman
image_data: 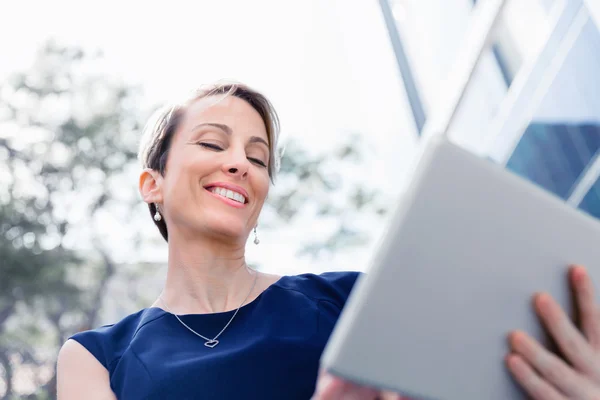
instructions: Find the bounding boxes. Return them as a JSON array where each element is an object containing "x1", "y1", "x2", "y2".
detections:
[{"x1": 72, "y1": 272, "x2": 359, "y2": 400}]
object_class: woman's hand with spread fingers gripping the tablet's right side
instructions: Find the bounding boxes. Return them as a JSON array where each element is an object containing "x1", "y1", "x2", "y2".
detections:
[{"x1": 506, "y1": 267, "x2": 600, "y2": 400}]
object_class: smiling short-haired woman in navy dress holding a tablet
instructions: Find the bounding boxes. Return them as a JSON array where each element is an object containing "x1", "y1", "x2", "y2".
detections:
[{"x1": 58, "y1": 84, "x2": 600, "y2": 400}]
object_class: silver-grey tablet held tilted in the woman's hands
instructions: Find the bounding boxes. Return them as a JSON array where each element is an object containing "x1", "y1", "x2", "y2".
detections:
[{"x1": 321, "y1": 137, "x2": 600, "y2": 400}]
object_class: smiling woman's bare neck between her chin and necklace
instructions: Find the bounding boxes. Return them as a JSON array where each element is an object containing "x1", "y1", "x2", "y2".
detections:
[{"x1": 160, "y1": 233, "x2": 258, "y2": 314}]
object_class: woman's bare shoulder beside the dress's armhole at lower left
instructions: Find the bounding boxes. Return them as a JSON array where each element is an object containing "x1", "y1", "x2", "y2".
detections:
[{"x1": 57, "y1": 339, "x2": 116, "y2": 400}]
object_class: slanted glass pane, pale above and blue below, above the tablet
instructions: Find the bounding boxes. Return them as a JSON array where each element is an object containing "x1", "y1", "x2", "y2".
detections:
[{"x1": 486, "y1": 7, "x2": 600, "y2": 199}]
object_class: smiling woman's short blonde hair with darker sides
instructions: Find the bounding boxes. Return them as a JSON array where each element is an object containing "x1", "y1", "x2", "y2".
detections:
[{"x1": 138, "y1": 82, "x2": 280, "y2": 241}]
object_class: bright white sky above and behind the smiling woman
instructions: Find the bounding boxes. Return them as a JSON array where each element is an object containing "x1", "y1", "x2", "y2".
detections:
[{"x1": 0, "y1": 0, "x2": 416, "y2": 273}]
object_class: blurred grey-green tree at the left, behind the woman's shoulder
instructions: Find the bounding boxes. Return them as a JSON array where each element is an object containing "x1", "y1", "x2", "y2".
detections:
[{"x1": 0, "y1": 43, "x2": 139, "y2": 398}]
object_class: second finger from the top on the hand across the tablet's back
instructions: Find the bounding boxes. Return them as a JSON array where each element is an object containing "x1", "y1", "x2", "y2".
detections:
[{"x1": 535, "y1": 294, "x2": 595, "y2": 376}]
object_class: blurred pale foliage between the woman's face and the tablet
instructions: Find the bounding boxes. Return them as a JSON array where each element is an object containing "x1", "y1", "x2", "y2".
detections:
[{"x1": 261, "y1": 134, "x2": 387, "y2": 260}]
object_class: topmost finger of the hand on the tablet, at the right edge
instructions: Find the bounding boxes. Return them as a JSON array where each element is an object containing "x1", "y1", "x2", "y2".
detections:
[{"x1": 571, "y1": 266, "x2": 600, "y2": 350}]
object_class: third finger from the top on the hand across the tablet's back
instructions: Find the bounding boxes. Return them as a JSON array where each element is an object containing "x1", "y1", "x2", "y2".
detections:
[{"x1": 509, "y1": 332, "x2": 595, "y2": 399}]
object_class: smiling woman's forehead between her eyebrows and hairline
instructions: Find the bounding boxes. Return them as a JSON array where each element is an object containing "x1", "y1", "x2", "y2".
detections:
[{"x1": 182, "y1": 96, "x2": 267, "y2": 139}]
